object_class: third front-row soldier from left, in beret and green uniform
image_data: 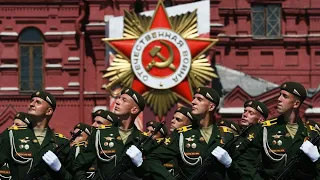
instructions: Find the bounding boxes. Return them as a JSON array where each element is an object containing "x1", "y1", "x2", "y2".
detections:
[{"x1": 144, "y1": 87, "x2": 238, "y2": 179}]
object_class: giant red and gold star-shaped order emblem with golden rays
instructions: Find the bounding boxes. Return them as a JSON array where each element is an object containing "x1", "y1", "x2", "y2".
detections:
[{"x1": 103, "y1": 0, "x2": 217, "y2": 118}]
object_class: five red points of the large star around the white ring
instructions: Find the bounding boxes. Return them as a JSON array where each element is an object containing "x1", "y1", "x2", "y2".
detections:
[{"x1": 108, "y1": 1, "x2": 214, "y2": 102}]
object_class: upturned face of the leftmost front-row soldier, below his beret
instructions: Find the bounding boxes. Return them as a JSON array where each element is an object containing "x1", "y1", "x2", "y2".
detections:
[{"x1": 28, "y1": 97, "x2": 53, "y2": 116}]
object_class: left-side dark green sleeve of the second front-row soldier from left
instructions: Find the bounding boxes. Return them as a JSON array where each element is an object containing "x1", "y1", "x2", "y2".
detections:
[{"x1": 72, "y1": 131, "x2": 97, "y2": 180}]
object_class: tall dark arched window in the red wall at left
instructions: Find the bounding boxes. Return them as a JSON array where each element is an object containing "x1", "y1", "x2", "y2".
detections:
[{"x1": 19, "y1": 27, "x2": 43, "y2": 91}]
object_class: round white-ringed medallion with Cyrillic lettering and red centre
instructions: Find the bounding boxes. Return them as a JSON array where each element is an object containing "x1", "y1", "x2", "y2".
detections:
[{"x1": 131, "y1": 28, "x2": 192, "y2": 89}]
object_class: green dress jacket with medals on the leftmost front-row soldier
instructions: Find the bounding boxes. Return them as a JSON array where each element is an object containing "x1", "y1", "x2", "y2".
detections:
[{"x1": 0, "y1": 126, "x2": 72, "y2": 180}]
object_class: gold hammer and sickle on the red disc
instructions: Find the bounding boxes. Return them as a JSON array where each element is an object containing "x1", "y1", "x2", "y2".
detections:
[{"x1": 146, "y1": 41, "x2": 176, "y2": 71}]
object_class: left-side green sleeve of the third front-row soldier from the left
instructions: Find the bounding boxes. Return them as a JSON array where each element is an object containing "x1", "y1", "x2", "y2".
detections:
[{"x1": 143, "y1": 132, "x2": 179, "y2": 180}]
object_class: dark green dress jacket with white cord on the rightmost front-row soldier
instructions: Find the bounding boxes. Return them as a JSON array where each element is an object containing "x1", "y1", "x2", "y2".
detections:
[{"x1": 236, "y1": 116, "x2": 320, "y2": 180}]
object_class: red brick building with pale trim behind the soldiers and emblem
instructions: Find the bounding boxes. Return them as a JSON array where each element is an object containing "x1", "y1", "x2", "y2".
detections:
[{"x1": 0, "y1": 0, "x2": 320, "y2": 134}]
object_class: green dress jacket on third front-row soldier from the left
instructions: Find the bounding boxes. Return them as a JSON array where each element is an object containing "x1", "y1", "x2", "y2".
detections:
[{"x1": 144, "y1": 124, "x2": 233, "y2": 180}]
